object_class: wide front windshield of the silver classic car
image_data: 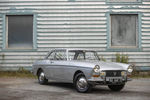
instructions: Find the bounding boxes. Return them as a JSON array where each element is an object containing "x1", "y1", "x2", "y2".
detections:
[{"x1": 68, "y1": 50, "x2": 99, "y2": 60}]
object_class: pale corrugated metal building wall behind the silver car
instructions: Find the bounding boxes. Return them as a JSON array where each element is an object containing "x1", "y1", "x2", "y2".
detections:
[{"x1": 0, "y1": 0, "x2": 150, "y2": 70}]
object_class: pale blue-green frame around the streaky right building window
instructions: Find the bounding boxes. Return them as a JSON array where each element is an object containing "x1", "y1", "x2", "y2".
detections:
[{"x1": 107, "y1": 12, "x2": 141, "y2": 51}]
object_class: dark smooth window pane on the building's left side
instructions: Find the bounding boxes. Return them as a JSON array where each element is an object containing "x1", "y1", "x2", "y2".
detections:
[{"x1": 6, "y1": 15, "x2": 33, "y2": 49}]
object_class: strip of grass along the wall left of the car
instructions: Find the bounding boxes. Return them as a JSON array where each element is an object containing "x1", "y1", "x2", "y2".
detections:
[{"x1": 0, "y1": 67, "x2": 36, "y2": 78}]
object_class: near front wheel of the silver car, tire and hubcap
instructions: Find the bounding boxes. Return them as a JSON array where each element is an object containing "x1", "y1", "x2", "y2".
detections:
[{"x1": 74, "y1": 73, "x2": 92, "y2": 93}]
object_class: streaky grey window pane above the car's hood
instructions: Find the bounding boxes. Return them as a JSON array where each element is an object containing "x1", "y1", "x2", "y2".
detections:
[{"x1": 110, "y1": 14, "x2": 138, "y2": 48}]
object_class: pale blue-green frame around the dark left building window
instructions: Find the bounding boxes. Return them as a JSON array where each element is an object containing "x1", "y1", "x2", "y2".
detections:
[{"x1": 2, "y1": 12, "x2": 37, "y2": 51}]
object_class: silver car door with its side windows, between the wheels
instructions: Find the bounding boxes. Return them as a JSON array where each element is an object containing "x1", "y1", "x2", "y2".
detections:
[{"x1": 46, "y1": 50, "x2": 67, "y2": 81}]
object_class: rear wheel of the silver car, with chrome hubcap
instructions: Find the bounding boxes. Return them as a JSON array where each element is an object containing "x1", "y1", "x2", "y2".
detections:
[{"x1": 38, "y1": 70, "x2": 48, "y2": 85}]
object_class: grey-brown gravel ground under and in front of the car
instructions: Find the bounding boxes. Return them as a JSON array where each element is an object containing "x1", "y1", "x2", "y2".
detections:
[{"x1": 0, "y1": 78, "x2": 150, "y2": 100}]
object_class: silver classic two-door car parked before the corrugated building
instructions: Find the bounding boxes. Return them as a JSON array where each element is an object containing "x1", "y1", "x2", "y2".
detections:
[{"x1": 33, "y1": 49, "x2": 133, "y2": 93}]
